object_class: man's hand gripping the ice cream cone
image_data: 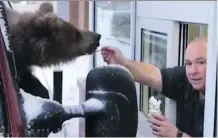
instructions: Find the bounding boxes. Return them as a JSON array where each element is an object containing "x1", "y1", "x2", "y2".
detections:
[{"x1": 148, "y1": 114, "x2": 178, "y2": 137}]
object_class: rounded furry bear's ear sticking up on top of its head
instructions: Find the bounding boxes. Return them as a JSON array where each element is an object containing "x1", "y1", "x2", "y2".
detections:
[{"x1": 38, "y1": 2, "x2": 54, "y2": 15}]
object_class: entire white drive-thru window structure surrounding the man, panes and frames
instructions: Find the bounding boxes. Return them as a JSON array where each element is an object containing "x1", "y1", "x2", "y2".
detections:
[{"x1": 89, "y1": 1, "x2": 217, "y2": 136}]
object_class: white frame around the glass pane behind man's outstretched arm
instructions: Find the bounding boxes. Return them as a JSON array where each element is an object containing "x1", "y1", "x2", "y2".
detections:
[{"x1": 136, "y1": 17, "x2": 179, "y2": 136}]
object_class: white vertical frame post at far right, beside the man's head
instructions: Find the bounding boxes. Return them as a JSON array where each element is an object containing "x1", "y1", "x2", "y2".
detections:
[{"x1": 204, "y1": 1, "x2": 218, "y2": 137}]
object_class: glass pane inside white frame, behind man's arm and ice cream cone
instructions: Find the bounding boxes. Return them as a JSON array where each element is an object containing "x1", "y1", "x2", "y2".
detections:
[{"x1": 140, "y1": 29, "x2": 167, "y2": 115}]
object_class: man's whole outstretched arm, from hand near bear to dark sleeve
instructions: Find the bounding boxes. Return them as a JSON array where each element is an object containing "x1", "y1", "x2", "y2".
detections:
[{"x1": 101, "y1": 47, "x2": 185, "y2": 95}]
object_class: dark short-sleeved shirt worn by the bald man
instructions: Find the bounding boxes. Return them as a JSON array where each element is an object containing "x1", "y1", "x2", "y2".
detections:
[{"x1": 161, "y1": 67, "x2": 204, "y2": 137}]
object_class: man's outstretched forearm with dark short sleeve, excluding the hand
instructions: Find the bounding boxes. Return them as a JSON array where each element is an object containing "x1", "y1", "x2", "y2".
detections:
[{"x1": 122, "y1": 59, "x2": 186, "y2": 100}]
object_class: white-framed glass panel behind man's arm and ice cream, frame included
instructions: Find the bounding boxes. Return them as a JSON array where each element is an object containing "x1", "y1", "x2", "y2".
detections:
[{"x1": 136, "y1": 18, "x2": 179, "y2": 136}]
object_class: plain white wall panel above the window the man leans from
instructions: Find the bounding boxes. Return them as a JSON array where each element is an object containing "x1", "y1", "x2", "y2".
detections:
[{"x1": 137, "y1": 1, "x2": 213, "y2": 23}]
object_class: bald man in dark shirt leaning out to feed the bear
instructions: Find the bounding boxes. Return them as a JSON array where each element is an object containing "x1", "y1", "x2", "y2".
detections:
[{"x1": 101, "y1": 38, "x2": 207, "y2": 137}]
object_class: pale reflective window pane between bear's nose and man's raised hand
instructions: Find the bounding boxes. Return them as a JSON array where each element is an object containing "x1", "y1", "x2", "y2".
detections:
[{"x1": 95, "y1": 1, "x2": 132, "y2": 66}]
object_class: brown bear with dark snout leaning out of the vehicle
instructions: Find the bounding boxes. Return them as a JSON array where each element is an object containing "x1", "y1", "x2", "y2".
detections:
[{"x1": 6, "y1": 2, "x2": 101, "y2": 98}]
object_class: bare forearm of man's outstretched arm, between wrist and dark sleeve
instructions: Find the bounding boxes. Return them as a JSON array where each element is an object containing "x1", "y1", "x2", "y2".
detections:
[{"x1": 123, "y1": 59, "x2": 162, "y2": 92}]
